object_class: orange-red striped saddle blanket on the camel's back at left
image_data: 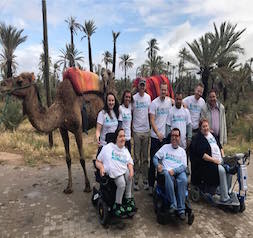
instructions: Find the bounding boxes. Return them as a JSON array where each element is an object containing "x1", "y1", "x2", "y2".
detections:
[{"x1": 63, "y1": 67, "x2": 100, "y2": 94}]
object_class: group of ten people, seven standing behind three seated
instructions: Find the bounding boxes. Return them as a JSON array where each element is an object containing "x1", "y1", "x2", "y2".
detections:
[{"x1": 96, "y1": 79, "x2": 230, "y2": 220}]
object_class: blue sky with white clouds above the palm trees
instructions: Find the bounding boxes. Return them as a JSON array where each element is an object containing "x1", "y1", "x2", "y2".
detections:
[{"x1": 0, "y1": 0, "x2": 253, "y2": 78}]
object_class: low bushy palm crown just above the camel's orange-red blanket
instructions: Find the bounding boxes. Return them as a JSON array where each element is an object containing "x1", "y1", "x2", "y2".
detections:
[{"x1": 56, "y1": 44, "x2": 84, "y2": 71}]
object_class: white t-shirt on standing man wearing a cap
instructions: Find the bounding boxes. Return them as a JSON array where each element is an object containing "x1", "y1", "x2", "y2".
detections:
[{"x1": 132, "y1": 93, "x2": 151, "y2": 132}]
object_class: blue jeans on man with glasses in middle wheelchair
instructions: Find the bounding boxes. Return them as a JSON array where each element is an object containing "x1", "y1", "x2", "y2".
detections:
[{"x1": 162, "y1": 170, "x2": 187, "y2": 214}]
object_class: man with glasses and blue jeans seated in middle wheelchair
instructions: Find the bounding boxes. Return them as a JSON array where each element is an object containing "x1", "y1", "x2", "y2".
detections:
[{"x1": 153, "y1": 128, "x2": 187, "y2": 220}]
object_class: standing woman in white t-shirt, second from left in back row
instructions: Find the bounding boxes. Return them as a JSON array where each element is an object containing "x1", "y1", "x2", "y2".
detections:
[{"x1": 119, "y1": 90, "x2": 133, "y2": 154}]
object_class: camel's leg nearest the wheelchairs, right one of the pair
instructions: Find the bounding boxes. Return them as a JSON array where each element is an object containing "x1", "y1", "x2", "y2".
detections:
[{"x1": 75, "y1": 128, "x2": 91, "y2": 192}]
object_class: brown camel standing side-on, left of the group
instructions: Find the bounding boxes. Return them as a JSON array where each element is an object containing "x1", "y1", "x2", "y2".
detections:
[{"x1": 0, "y1": 70, "x2": 114, "y2": 194}]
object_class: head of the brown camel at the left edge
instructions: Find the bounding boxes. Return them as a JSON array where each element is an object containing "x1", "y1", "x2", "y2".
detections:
[{"x1": 0, "y1": 73, "x2": 35, "y2": 98}]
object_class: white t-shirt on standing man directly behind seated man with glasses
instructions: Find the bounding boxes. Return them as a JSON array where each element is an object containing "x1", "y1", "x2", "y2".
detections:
[{"x1": 166, "y1": 106, "x2": 192, "y2": 149}]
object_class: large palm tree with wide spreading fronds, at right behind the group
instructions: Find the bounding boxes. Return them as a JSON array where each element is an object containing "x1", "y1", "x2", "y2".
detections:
[{"x1": 183, "y1": 22, "x2": 245, "y2": 99}]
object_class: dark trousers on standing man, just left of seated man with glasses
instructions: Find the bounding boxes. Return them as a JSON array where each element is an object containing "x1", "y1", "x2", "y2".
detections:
[{"x1": 148, "y1": 137, "x2": 166, "y2": 187}]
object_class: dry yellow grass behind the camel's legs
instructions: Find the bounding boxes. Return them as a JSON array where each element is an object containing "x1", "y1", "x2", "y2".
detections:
[{"x1": 0, "y1": 120, "x2": 97, "y2": 166}]
